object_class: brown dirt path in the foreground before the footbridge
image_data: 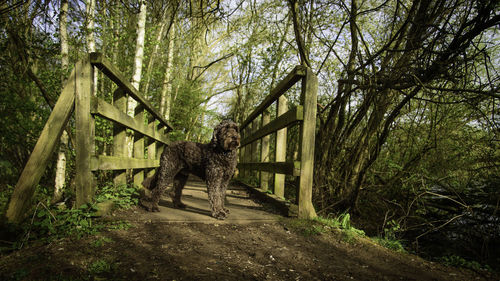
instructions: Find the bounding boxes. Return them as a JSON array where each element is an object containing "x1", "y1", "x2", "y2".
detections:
[{"x1": 0, "y1": 180, "x2": 498, "y2": 280}]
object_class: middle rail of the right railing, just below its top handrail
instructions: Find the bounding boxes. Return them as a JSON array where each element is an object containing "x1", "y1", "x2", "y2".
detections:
[{"x1": 241, "y1": 105, "x2": 304, "y2": 146}]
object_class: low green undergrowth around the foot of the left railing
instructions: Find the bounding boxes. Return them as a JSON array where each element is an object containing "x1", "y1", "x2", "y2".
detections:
[{"x1": 0, "y1": 182, "x2": 138, "y2": 252}]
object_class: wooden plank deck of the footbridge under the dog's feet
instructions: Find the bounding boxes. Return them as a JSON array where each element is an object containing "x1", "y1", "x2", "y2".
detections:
[{"x1": 134, "y1": 176, "x2": 279, "y2": 224}]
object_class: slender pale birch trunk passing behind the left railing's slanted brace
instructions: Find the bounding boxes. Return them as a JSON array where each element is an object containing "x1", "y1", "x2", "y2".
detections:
[{"x1": 52, "y1": 0, "x2": 69, "y2": 203}]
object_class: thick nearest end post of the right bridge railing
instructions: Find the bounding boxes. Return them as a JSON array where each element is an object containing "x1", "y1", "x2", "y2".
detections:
[{"x1": 299, "y1": 68, "x2": 318, "y2": 219}]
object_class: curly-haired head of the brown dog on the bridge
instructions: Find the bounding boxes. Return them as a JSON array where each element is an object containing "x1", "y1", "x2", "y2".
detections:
[{"x1": 210, "y1": 120, "x2": 240, "y2": 151}]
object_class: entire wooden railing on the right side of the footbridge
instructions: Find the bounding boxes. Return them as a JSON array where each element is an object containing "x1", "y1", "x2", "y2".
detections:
[{"x1": 238, "y1": 66, "x2": 318, "y2": 218}]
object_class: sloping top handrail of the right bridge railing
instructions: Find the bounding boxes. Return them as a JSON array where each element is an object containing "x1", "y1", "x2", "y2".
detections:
[{"x1": 240, "y1": 65, "x2": 306, "y2": 129}]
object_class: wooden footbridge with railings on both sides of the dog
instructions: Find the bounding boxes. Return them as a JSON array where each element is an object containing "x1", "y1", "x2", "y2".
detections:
[{"x1": 6, "y1": 53, "x2": 317, "y2": 222}]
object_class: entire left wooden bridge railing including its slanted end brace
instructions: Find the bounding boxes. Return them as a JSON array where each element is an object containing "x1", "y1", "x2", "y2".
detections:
[{"x1": 6, "y1": 53, "x2": 172, "y2": 222}]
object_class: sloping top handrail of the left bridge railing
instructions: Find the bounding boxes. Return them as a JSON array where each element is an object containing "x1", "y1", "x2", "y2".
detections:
[{"x1": 90, "y1": 53, "x2": 173, "y2": 132}]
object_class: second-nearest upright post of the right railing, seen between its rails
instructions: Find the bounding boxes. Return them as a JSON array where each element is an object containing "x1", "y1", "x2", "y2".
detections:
[{"x1": 274, "y1": 96, "x2": 288, "y2": 198}]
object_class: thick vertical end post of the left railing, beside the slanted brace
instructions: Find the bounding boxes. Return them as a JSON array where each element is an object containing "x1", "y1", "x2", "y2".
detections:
[{"x1": 75, "y1": 60, "x2": 95, "y2": 207}]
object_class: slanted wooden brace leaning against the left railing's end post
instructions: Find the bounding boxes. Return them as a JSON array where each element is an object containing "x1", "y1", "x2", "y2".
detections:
[{"x1": 5, "y1": 62, "x2": 82, "y2": 223}]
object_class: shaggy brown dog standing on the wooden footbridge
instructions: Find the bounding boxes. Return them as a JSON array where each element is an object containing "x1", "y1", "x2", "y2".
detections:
[{"x1": 141, "y1": 120, "x2": 240, "y2": 220}]
